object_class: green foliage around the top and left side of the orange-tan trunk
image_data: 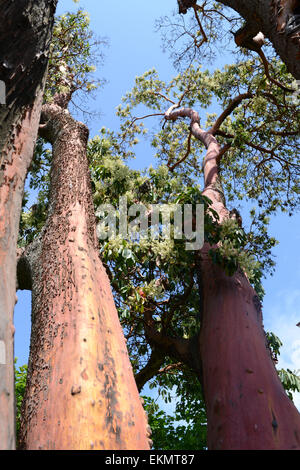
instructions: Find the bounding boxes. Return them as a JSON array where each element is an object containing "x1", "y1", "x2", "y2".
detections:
[{"x1": 19, "y1": 9, "x2": 106, "y2": 246}]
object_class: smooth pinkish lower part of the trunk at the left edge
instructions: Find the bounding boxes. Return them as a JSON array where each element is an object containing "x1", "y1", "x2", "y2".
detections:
[{"x1": 0, "y1": 95, "x2": 45, "y2": 450}]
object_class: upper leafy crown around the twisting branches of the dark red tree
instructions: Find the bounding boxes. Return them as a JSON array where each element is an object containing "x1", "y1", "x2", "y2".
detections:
[{"x1": 118, "y1": 59, "x2": 300, "y2": 215}]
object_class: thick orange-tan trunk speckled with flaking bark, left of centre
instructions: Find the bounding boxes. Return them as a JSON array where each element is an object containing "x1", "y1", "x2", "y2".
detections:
[{"x1": 17, "y1": 104, "x2": 149, "y2": 450}]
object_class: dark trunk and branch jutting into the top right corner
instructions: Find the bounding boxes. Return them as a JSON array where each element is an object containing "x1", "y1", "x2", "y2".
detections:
[{"x1": 178, "y1": 0, "x2": 300, "y2": 79}]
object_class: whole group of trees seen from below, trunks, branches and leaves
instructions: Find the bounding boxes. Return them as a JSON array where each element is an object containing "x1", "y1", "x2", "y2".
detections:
[{"x1": 0, "y1": 0, "x2": 300, "y2": 450}]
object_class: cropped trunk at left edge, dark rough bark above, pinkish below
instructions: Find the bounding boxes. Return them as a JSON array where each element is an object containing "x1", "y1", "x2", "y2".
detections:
[{"x1": 0, "y1": 0, "x2": 56, "y2": 450}]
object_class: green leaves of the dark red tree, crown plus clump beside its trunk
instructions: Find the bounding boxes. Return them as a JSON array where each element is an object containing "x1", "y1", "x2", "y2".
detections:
[{"x1": 113, "y1": 58, "x2": 300, "y2": 299}]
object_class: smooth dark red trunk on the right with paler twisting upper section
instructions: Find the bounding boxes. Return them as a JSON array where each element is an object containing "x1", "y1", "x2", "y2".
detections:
[{"x1": 197, "y1": 123, "x2": 300, "y2": 450}]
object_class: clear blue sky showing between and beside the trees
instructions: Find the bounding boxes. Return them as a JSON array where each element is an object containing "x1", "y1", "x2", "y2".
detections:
[{"x1": 15, "y1": 0, "x2": 300, "y2": 409}]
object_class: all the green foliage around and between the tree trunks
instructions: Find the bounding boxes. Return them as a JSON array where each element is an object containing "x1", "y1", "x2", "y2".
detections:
[{"x1": 15, "y1": 2, "x2": 300, "y2": 450}]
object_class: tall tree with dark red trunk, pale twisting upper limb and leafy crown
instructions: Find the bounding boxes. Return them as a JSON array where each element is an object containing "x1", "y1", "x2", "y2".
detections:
[{"x1": 109, "y1": 61, "x2": 300, "y2": 449}]
